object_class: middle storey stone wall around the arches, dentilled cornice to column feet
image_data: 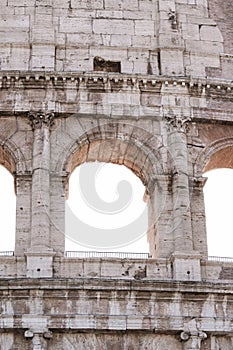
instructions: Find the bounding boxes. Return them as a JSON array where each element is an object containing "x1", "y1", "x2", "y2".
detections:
[{"x1": 0, "y1": 72, "x2": 232, "y2": 262}]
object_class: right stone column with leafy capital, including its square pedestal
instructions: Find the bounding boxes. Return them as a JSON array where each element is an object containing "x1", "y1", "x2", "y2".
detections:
[{"x1": 166, "y1": 114, "x2": 201, "y2": 280}]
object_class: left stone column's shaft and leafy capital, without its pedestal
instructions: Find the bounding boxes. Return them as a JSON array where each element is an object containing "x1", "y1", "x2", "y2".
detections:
[{"x1": 29, "y1": 112, "x2": 54, "y2": 252}]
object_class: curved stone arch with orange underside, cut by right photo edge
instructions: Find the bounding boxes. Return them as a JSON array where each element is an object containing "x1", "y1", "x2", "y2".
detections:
[{"x1": 195, "y1": 137, "x2": 233, "y2": 177}]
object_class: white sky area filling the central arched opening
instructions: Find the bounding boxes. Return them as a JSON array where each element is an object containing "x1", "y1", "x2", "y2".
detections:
[{"x1": 65, "y1": 162, "x2": 149, "y2": 253}]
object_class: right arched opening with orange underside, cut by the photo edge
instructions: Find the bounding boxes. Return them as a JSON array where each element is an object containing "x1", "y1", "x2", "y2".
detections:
[{"x1": 203, "y1": 146, "x2": 233, "y2": 257}]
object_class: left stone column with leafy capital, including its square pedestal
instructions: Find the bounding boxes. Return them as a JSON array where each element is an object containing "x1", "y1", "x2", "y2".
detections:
[{"x1": 27, "y1": 112, "x2": 54, "y2": 277}]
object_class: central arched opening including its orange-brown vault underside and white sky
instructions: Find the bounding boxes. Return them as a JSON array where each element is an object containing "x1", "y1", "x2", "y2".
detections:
[{"x1": 64, "y1": 132, "x2": 161, "y2": 255}]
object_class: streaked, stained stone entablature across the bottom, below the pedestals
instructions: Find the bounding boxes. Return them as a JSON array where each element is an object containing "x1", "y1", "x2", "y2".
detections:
[{"x1": 0, "y1": 279, "x2": 232, "y2": 350}]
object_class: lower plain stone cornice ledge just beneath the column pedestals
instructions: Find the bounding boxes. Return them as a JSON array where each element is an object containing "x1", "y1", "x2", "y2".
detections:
[{"x1": 0, "y1": 277, "x2": 233, "y2": 298}]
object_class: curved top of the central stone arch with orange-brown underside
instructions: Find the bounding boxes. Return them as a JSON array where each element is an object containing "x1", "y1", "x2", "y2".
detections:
[{"x1": 57, "y1": 124, "x2": 165, "y2": 194}]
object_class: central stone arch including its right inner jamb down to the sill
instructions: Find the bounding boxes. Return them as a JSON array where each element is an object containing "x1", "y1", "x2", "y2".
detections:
[{"x1": 54, "y1": 118, "x2": 169, "y2": 256}]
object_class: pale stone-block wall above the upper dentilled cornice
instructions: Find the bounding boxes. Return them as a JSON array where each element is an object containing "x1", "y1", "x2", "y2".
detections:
[{"x1": 0, "y1": 0, "x2": 228, "y2": 76}]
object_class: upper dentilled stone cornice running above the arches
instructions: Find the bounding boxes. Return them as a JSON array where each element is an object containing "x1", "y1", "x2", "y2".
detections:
[{"x1": 0, "y1": 71, "x2": 233, "y2": 94}]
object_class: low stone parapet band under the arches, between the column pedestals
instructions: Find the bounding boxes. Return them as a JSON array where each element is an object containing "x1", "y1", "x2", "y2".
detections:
[{"x1": 3, "y1": 257, "x2": 233, "y2": 284}]
